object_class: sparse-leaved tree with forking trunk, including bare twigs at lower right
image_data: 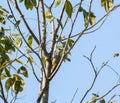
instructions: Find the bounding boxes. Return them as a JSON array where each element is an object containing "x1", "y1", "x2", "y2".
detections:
[{"x1": 0, "y1": 0, "x2": 120, "y2": 103}]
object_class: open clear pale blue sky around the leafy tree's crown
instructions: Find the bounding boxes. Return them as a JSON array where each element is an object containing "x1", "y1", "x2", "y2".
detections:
[{"x1": 0, "y1": 0, "x2": 120, "y2": 103}]
